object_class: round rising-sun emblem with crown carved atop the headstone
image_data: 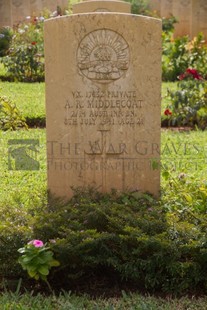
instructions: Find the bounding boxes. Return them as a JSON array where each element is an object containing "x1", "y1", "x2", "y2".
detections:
[{"x1": 77, "y1": 29, "x2": 129, "y2": 83}]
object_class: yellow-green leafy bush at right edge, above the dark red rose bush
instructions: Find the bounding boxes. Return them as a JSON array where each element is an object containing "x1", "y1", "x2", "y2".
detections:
[{"x1": 162, "y1": 31, "x2": 207, "y2": 81}]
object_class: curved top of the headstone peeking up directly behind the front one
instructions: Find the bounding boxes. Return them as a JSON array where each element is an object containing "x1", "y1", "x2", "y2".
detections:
[{"x1": 73, "y1": 0, "x2": 131, "y2": 14}]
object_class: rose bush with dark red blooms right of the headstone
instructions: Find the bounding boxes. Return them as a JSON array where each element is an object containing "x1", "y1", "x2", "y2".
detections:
[{"x1": 164, "y1": 68, "x2": 207, "y2": 127}]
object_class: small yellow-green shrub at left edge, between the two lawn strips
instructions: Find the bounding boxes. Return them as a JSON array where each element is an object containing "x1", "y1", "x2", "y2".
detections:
[{"x1": 0, "y1": 96, "x2": 27, "y2": 130}]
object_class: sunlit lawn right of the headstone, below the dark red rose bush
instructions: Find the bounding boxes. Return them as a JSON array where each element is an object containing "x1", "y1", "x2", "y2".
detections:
[{"x1": 161, "y1": 129, "x2": 207, "y2": 178}]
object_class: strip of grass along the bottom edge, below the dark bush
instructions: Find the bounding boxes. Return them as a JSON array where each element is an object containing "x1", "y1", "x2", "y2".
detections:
[{"x1": 0, "y1": 292, "x2": 207, "y2": 310}]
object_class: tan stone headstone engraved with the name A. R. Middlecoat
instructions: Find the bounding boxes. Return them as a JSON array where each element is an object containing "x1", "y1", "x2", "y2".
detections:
[{"x1": 45, "y1": 12, "x2": 161, "y2": 198}]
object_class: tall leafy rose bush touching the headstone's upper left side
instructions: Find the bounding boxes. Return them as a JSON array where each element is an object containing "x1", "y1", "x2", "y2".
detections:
[{"x1": 2, "y1": 17, "x2": 44, "y2": 82}]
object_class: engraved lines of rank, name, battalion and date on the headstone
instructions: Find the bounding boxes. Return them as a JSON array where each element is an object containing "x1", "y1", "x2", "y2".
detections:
[{"x1": 64, "y1": 90, "x2": 144, "y2": 127}]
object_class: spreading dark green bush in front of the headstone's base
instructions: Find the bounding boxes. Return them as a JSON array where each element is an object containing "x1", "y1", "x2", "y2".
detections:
[{"x1": 30, "y1": 191, "x2": 207, "y2": 294}]
